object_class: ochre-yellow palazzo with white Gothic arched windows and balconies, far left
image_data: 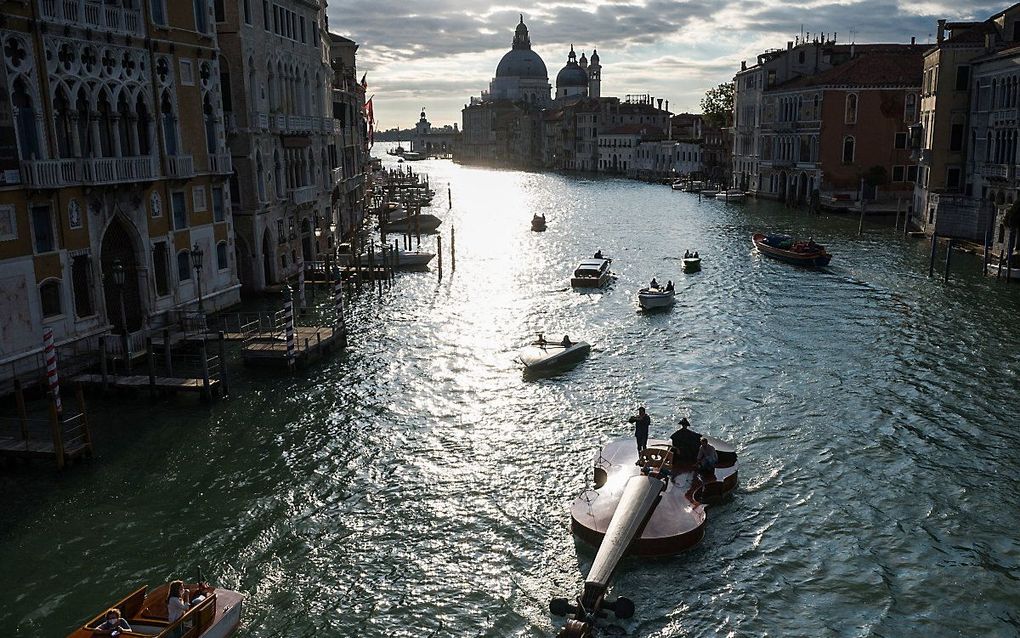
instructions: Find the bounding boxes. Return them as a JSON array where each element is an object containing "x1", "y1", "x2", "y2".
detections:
[{"x1": 0, "y1": 0, "x2": 240, "y2": 377}]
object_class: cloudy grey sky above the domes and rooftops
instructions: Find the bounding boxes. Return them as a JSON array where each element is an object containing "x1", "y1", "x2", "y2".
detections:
[{"x1": 328, "y1": 0, "x2": 1009, "y2": 129}]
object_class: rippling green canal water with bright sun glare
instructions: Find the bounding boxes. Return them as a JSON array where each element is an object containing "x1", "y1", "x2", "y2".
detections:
[{"x1": 0, "y1": 145, "x2": 1020, "y2": 638}]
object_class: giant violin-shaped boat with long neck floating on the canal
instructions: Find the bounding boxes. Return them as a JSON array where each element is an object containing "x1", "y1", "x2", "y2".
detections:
[{"x1": 549, "y1": 431, "x2": 736, "y2": 638}]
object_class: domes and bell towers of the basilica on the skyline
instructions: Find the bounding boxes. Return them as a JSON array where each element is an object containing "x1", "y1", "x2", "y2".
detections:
[{"x1": 482, "y1": 15, "x2": 602, "y2": 107}]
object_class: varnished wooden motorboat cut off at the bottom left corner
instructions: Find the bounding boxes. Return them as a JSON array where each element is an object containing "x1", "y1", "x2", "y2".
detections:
[{"x1": 67, "y1": 583, "x2": 244, "y2": 638}]
